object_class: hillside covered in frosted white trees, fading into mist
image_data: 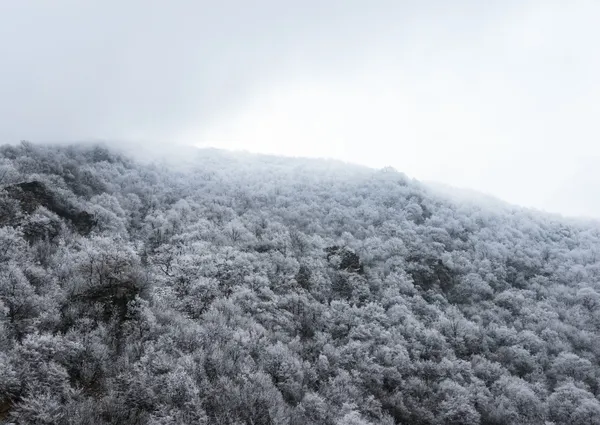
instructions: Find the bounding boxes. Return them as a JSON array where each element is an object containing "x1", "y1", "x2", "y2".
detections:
[{"x1": 0, "y1": 143, "x2": 600, "y2": 425}]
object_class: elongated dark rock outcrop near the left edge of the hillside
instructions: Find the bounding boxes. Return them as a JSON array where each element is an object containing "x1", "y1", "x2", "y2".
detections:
[{"x1": 4, "y1": 181, "x2": 96, "y2": 235}]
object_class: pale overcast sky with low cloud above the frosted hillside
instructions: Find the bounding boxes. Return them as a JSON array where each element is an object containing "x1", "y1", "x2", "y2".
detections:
[{"x1": 0, "y1": 0, "x2": 600, "y2": 218}]
